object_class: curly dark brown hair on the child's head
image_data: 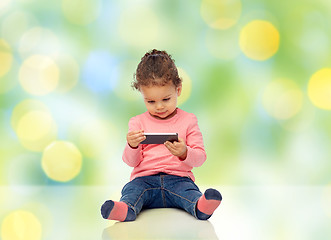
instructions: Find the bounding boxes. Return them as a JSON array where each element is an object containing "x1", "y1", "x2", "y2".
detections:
[{"x1": 131, "y1": 49, "x2": 182, "y2": 90}]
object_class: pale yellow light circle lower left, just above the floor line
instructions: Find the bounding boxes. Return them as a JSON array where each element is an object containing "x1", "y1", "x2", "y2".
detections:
[{"x1": 42, "y1": 141, "x2": 83, "y2": 182}]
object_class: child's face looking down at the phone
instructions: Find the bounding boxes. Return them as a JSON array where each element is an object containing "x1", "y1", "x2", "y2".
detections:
[{"x1": 140, "y1": 84, "x2": 182, "y2": 119}]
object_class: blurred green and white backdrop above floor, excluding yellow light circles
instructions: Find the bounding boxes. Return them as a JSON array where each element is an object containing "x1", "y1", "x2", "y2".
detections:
[{"x1": 0, "y1": 0, "x2": 331, "y2": 186}]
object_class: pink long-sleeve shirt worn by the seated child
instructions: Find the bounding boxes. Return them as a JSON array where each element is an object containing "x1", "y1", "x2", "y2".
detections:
[{"x1": 122, "y1": 108, "x2": 206, "y2": 181}]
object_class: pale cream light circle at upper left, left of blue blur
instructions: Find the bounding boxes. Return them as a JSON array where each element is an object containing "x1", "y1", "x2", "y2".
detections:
[{"x1": 19, "y1": 55, "x2": 59, "y2": 96}]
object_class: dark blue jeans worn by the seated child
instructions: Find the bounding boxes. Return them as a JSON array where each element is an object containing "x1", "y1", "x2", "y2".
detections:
[{"x1": 120, "y1": 173, "x2": 202, "y2": 218}]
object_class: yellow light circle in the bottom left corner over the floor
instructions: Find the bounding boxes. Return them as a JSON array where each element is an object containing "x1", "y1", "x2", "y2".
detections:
[{"x1": 1, "y1": 210, "x2": 42, "y2": 240}]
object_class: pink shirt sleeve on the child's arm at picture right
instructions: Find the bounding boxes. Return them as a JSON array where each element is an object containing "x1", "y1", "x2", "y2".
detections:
[{"x1": 183, "y1": 114, "x2": 207, "y2": 167}]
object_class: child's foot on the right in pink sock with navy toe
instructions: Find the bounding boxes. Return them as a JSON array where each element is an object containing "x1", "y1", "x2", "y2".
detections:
[{"x1": 196, "y1": 188, "x2": 222, "y2": 220}]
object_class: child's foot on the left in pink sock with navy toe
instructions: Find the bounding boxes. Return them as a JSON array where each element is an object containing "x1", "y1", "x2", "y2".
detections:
[{"x1": 101, "y1": 200, "x2": 136, "y2": 222}]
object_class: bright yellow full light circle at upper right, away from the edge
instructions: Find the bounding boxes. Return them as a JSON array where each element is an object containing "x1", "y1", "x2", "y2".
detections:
[{"x1": 239, "y1": 20, "x2": 280, "y2": 61}]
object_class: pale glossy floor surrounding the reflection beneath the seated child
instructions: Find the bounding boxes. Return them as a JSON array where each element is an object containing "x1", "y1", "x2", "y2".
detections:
[{"x1": 0, "y1": 186, "x2": 331, "y2": 240}]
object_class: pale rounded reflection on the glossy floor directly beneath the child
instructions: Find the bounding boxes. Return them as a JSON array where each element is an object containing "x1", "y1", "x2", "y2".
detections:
[{"x1": 102, "y1": 209, "x2": 218, "y2": 240}]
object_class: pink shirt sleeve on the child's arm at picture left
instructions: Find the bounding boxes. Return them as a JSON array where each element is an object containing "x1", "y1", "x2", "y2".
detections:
[{"x1": 122, "y1": 117, "x2": 142, "y2": 167}]
